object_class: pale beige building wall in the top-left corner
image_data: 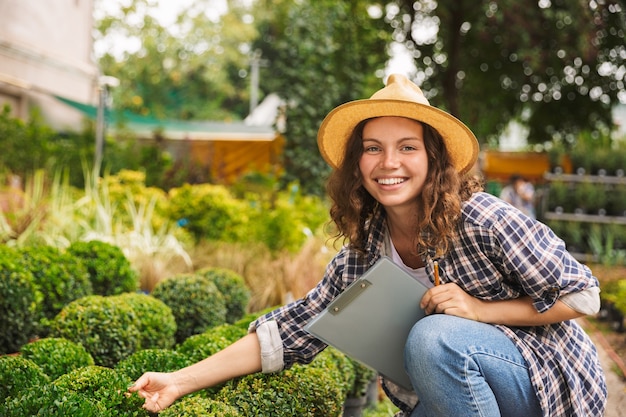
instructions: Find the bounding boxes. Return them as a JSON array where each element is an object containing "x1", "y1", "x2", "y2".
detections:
[{"x1": 0, "y1": 0, "x2": 98, "y2": 130}]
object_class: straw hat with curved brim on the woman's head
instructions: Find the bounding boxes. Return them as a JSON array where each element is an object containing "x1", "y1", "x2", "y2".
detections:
[{"x1": 317, "y1": 74, "x2": 478, "y2": 173}]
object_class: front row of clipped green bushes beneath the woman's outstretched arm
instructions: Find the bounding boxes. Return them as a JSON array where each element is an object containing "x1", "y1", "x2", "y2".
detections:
[{"x1": 0, "y1": 322, "x2": 355, "y2": 417}]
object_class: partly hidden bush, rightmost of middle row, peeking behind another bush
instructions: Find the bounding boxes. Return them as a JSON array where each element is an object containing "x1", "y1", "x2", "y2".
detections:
[{"x1": 196, "y1": 267, "x2": 250, "y2": 323}]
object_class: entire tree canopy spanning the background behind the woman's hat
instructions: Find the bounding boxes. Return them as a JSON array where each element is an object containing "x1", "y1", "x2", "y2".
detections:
[{"x1": 96, "y1": 0, "x2": 626, "y2": 192}]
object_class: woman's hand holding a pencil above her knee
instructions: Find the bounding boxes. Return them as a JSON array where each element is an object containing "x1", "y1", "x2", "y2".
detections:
[{"x1": 420, "y1": 283, "x2": 483, "y2": 321}]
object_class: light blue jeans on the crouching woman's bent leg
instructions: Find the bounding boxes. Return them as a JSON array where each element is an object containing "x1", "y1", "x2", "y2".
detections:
[{"x1": 404, "y1": 314, "x2": 542, "y2": 417}]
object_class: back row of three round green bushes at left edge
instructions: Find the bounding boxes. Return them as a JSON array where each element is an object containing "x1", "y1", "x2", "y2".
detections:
[{"x1": 0, "y1": 241, "x2": 138, "y2": 354}]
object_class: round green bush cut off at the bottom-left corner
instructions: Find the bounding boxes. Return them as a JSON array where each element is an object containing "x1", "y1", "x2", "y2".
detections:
[{"x1": 0, "y1": 384, "x2": 106, "y2": 417}]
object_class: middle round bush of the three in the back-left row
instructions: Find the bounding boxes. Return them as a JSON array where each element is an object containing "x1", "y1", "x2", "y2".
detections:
[{"x1": 19, "y1": 246, "x2": 93, "y2": 319}]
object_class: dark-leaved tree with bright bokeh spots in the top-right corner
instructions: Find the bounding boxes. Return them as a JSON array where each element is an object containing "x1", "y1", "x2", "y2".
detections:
[{"x1": 388, "y1": 0, "x2": 626, "y2": 143}]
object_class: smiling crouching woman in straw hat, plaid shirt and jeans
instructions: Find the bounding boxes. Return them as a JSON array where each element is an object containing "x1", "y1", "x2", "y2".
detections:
[{"x1": 130, "y1": 75, "x2": 606, "y2": 417}]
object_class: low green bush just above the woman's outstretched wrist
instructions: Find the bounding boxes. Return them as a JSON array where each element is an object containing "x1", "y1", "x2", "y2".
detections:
[{"x1": 115, "y1": 349, "x2": 193, "y2": 381}]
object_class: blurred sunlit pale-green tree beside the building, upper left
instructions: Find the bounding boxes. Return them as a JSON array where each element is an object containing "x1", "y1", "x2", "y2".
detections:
[{"x1": 95, "y1": 0, "x2": 256, "y2": 120}]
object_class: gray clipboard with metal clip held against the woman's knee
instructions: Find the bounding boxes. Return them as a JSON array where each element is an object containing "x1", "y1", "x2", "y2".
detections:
[{"x1": 304, "y1": 257, "x2": 428, "y2": 389}]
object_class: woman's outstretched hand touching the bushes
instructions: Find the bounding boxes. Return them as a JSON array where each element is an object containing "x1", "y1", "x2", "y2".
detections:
[{"x1": 128, "y1": 372, "x2": 181, "y2": 413}]
